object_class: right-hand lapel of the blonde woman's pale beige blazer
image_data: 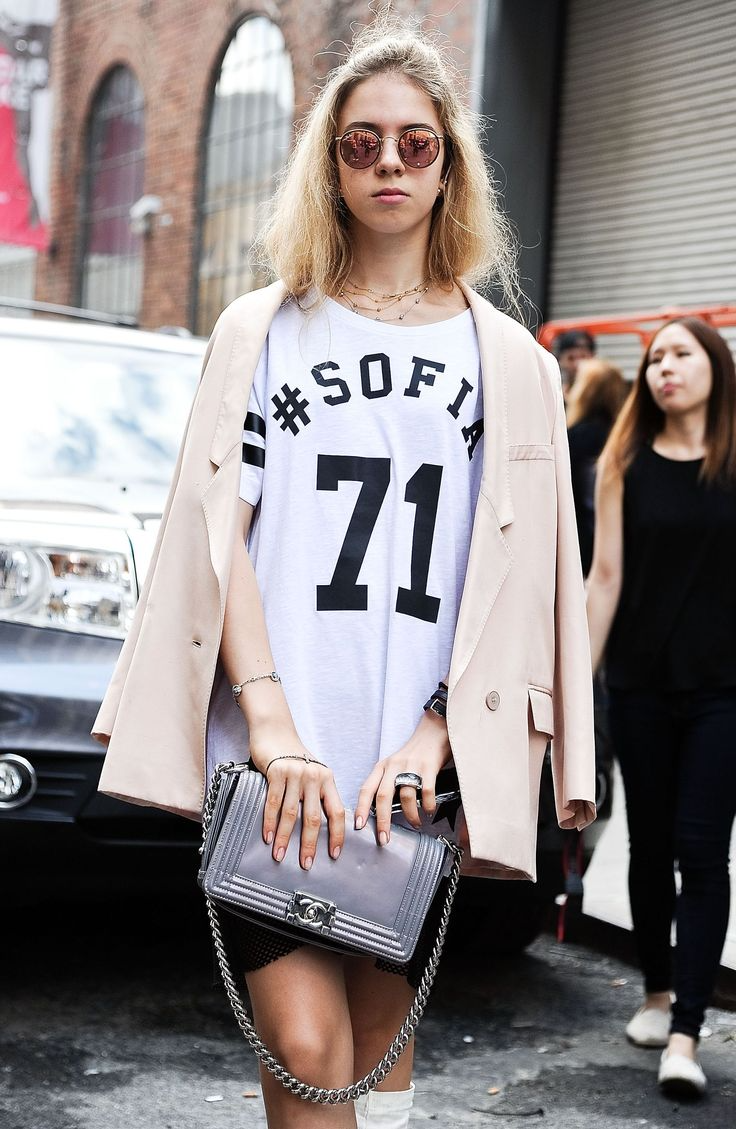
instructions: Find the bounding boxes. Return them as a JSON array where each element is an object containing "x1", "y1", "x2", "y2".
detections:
[{"x1": 449, "y1": 283, "x2": 514, "y2": 694}]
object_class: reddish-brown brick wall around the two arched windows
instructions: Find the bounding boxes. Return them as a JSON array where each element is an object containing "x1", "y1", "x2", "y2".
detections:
[{"x1": 36, "y1": 0, "x2": 477, "y2": 325}]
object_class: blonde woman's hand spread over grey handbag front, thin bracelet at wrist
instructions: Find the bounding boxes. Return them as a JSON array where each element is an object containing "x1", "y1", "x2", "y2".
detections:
[{"x1": 251, "y1": 730, "x2": 345, "y2": 870}]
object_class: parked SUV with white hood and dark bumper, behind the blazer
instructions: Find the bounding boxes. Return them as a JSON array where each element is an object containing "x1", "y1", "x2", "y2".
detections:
[{"x1": 0, "y1": 317, "x2": 205, "y2": 844}]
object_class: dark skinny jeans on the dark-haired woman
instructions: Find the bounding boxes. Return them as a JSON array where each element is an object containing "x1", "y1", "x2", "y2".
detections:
[{"x1": 610, "y1": 689, "x2": 736, "y2": 1039}]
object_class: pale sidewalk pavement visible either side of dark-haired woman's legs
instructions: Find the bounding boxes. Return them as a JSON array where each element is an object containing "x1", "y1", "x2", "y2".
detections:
[{"x1": 582, "y1": 768, "x2": 736, "y2": 969}]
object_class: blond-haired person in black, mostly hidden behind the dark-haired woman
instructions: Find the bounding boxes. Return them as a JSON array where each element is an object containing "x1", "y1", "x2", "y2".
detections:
[{"x1": 567, "y1": 357, "x2": 629, "y2": 576}]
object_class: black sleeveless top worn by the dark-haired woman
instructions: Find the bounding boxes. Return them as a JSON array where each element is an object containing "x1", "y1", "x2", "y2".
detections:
[{"x1": 606, "y1": 446, "x2": 736, "y2": 690}]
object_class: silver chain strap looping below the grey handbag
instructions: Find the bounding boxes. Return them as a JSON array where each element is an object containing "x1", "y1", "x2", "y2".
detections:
[{"x1": 201, "y1": 761, "x2": 463, "y2": 1105}]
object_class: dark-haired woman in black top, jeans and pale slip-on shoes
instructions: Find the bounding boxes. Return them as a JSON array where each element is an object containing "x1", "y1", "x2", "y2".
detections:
[{"x1": 588, "y1": 317, "x2": 736, "y2": 1096}]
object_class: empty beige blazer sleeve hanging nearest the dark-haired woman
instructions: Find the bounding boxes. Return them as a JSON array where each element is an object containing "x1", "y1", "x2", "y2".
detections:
[{"x1": 544, "y1": 352, "x2": 596, "y2": 830}]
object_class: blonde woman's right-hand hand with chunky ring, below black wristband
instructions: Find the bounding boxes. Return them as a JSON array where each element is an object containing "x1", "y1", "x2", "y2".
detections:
[{"x1": 356, "y1": 710, "x2": 452, "y2": 846}]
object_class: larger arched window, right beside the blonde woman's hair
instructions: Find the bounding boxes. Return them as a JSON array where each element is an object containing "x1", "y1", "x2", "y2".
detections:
[{"x1": 194, "y1": 16, "x2": 293, "y2": 333}]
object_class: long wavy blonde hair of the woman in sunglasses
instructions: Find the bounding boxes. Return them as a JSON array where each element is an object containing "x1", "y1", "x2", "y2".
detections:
[{"x1": 260, "y1": 15, "x2": 522, "y2": 317}]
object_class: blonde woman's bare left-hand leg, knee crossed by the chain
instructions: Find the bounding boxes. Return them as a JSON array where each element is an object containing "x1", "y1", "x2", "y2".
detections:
[{"x1": 246, "y1": 945, "x2": 356, "y2": 1129}]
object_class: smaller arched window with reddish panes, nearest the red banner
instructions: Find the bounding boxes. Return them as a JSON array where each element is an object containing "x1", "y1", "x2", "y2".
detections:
[{"x1": 77, "y1": 67, "x2": 144, "y2": 316}]
